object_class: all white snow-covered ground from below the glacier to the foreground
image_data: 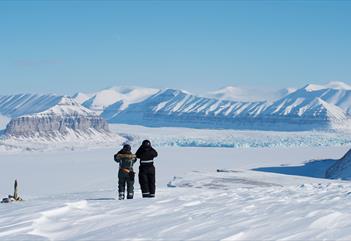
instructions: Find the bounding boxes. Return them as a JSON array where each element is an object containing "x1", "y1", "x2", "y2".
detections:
[{"x1": 0, "y1": 145, "x2": 351, "y2": 240}]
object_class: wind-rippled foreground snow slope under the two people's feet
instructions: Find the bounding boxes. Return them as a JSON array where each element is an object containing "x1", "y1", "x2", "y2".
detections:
[{"x1": 0, "y1": 171, "x2": 351, "y2": 240}]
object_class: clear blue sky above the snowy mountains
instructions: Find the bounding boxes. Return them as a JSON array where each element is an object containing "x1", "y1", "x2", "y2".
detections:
[{"x1": 0, "y1": 1, "x2": 351, "y2": 94}]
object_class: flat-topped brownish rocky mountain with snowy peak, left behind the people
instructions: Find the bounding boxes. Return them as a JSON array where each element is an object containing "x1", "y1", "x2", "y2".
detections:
[{"x1": 5, "y1": 97, "x2": 109, "y2": 136}]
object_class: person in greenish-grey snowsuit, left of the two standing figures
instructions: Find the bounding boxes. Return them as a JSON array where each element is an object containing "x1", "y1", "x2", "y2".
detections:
[{"x1": 114, "y1": 144, "x2": 137, "y2": 200}]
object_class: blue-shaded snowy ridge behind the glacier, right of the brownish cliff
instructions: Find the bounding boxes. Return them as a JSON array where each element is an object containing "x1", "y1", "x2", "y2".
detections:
[{"x1": 106, "y1": 82, "x2": 351, "y2": 131}]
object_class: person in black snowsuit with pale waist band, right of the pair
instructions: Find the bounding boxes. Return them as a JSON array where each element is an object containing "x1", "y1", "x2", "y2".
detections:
[{"x1": 135, "y1": 140, "x2": 158, "y2": 198}]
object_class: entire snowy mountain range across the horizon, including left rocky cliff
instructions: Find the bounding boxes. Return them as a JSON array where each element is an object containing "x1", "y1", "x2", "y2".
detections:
[{"x1": 0, "y1": 82, "x2": 351, "y2": 135}]
